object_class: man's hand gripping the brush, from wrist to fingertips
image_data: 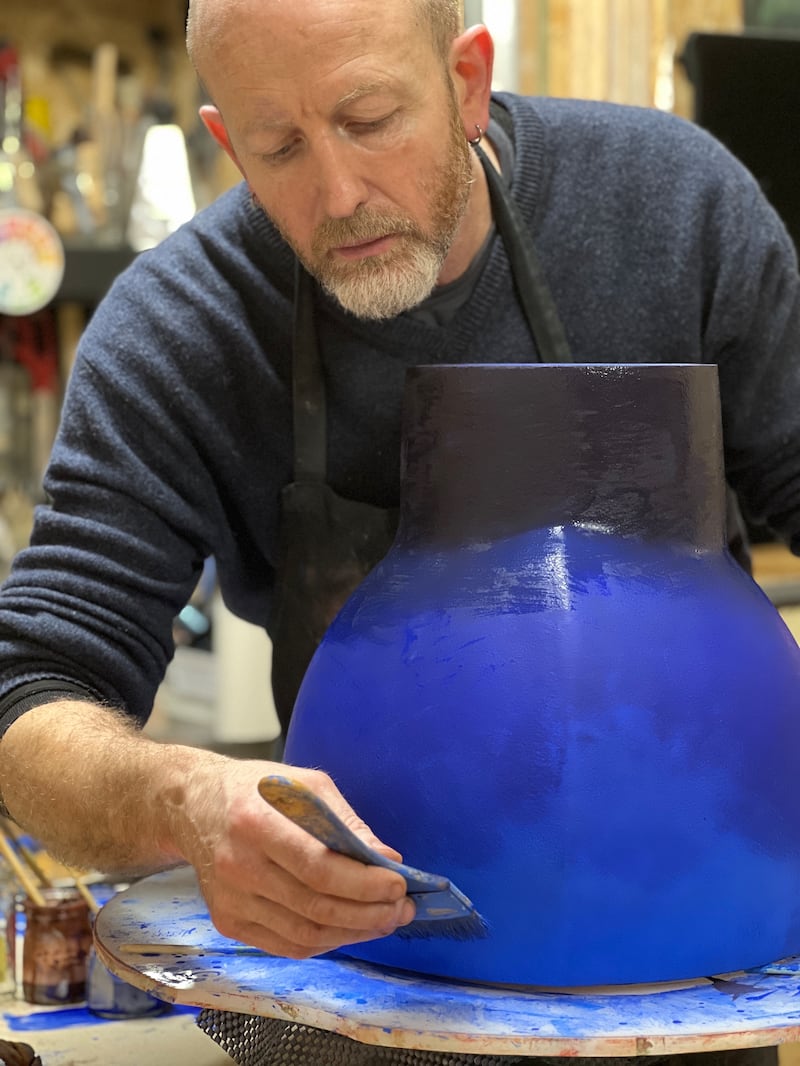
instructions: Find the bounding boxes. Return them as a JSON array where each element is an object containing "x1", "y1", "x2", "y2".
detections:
[{"x1": 166, "y1": 760, "x2": 414, "y2": 958}]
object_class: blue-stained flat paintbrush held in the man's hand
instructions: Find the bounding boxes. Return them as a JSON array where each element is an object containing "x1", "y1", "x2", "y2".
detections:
[{"x1": 258, "y1": 774, "x2": 487, "y2": 940}]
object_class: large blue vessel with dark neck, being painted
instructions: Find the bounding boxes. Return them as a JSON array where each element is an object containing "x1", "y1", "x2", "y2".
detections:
[{"x1": 286, "y1": 365, "x2": 800, "y2": 986}]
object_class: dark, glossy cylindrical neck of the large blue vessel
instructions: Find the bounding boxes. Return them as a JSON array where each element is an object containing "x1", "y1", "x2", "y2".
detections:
[{"x1": 398, "y1": 364, "x2": 724, "y2": 550}]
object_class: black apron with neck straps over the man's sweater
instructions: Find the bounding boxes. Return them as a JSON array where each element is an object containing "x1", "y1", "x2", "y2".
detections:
[{"x1": 270, "y1": 149, "x2": 571, "y2": 736}]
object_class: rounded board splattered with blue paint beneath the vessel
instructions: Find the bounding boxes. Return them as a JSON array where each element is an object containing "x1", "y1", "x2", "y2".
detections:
[{"x1": 96, "y1": 869, "x2": 800, "y2": 1056}]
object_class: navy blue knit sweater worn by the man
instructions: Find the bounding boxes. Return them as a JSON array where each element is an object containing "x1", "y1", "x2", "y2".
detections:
[{"x1": 0, "y1": 96, "x2": 800, "y2": 725}]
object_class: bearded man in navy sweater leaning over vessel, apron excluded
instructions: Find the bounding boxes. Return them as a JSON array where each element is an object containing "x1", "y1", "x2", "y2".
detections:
[{"x1": 0, "y1": 0, "x2": 800, "y2": 976}]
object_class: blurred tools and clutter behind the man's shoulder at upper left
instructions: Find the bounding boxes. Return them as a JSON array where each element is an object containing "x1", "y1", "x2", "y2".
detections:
[{"x1": 0, "y1": 4, "x2": 226, "y2": 578}]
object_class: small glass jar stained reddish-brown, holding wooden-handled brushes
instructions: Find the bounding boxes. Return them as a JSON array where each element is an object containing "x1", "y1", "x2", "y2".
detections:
[{"x1": 22, "y1": 888, "x2": 92, "y2": 1006}]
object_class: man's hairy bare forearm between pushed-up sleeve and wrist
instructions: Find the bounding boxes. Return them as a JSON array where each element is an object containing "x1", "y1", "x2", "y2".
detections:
[{"x1": 0, "y1": 701, "x2": 225, "y2": 874}]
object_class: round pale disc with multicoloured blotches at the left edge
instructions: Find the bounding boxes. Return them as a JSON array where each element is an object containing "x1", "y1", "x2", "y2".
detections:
[{"x1": 0, "y1": 208, "x2": 64, "y2": 314}]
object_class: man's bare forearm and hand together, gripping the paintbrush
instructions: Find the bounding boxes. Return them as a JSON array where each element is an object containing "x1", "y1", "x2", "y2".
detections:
[{"x1": 0, "y1": 701, "x2": 414, "y2": 958}]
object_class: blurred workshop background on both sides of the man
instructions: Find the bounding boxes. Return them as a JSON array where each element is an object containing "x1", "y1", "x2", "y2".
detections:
[{"x1": 0, "y1": 0, "x2": 800, "y2": 1066}]
